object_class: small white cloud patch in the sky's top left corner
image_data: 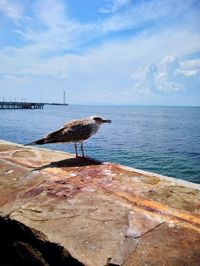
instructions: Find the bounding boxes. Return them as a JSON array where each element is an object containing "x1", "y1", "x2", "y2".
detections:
[{"x1": 0, "y1": 0, "x2": 23, "y2": 21}]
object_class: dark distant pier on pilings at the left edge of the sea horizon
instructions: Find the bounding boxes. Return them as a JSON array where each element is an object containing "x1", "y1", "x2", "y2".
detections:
[{"x1": 0, "y1": 102, "x2": 44, "y2": 109}]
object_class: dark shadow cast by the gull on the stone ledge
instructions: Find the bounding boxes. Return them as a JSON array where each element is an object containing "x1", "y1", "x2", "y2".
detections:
[{"x1": 32, "y1": 157, "x2": 102, "y2": 172}]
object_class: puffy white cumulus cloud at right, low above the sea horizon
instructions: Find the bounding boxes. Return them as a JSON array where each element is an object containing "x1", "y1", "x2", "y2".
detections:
[{"x1": 132, "y1": 56, "x2": 200, "y2": 94}]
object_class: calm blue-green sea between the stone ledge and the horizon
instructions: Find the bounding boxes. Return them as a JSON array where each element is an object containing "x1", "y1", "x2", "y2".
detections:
[{"x1": 0, "y1": 105, "x2": 200, "y2": 183}]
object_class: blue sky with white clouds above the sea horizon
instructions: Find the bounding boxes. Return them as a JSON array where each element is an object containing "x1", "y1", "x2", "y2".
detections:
[{"x1": 0, "y1": 0, "x2": 200, "y2": 106}]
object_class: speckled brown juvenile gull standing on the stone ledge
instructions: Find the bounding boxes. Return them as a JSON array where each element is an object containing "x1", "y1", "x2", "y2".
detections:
[{"x1": 26, "y1": 116, "x2": 111, "y2": 158}]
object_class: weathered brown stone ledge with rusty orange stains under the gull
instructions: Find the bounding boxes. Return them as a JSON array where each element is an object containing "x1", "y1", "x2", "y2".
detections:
[{"x1": 0, "y1": 141, "x2": 200, "y2": 266}]
